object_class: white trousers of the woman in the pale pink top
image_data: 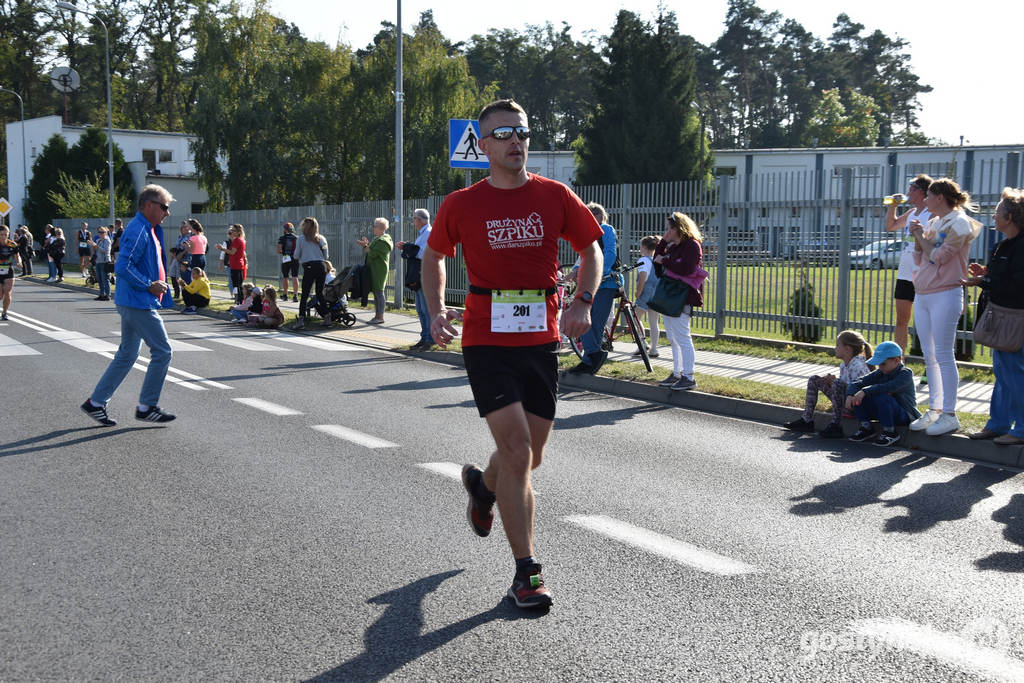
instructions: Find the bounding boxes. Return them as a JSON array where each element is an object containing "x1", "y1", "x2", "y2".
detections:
[{"x1": 913, "y1": 287, "x2": 964, "y2": 413}]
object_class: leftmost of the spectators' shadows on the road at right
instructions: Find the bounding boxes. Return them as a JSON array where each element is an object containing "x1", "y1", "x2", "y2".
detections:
[{"x1": 790, "y1": 455, "x2": 935, "y2": 517}]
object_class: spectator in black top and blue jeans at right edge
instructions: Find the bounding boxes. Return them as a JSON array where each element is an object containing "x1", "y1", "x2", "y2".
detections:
[{"x1": 964, "y1": 187, "x2": 1024, "y2": 445}]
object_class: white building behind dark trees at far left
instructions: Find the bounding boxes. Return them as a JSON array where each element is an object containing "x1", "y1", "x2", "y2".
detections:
[{"x1": 7, "y1": 116, "x2": 209, "y2": 225}]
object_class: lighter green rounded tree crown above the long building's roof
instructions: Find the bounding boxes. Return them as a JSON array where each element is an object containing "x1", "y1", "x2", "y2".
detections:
[{"x1": 803, "y1": 88, "x2": 879, "y2": 147}]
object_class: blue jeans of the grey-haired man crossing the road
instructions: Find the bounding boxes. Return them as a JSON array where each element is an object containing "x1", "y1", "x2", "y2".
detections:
[{"x1": 90, "y1": 306, "x2": 171, "y2": 405}]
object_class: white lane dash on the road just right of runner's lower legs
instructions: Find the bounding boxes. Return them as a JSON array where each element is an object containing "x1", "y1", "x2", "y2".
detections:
[{"x1": 565, "y1": 515, "x2": 758, "y2": 575}]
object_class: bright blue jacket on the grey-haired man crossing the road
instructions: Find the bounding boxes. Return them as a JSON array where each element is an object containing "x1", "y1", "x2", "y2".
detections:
[{"x1": 114, "y1": 212, "x2": 174, "y2": 309}]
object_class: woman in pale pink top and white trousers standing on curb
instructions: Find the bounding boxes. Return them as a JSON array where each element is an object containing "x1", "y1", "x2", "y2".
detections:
[{"x1": 910, "y1": 178, "x2": 981, "y2": 436}]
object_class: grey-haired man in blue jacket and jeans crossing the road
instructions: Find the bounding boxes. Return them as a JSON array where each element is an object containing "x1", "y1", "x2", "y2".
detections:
[{"x1": 82, "y1": 185, "x2": 174, "y2": 427}]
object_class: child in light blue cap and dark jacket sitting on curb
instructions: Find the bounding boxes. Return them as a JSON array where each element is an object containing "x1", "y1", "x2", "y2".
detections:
[{"x1": 846, "y1": 341, "x2": 921, "y2": 445}]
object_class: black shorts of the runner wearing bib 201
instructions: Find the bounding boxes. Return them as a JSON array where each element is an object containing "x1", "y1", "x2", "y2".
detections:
[{"x1": 462, "y1": 342, "x2": 558, "y2": 420}]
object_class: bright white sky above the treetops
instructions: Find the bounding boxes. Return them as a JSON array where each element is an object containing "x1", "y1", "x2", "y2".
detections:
[{"x1": 269, "y1": 0, "x2": 1024, "y2": 144}]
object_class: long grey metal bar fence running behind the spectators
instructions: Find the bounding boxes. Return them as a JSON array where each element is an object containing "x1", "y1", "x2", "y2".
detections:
[{"x1": 54, "y1": 153, "x2": 1022, "y2": 361}]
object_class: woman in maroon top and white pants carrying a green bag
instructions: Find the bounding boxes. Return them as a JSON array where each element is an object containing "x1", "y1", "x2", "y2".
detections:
[{"x1": 653, "y1": 211, "x2": 703, "y2": 391}]
